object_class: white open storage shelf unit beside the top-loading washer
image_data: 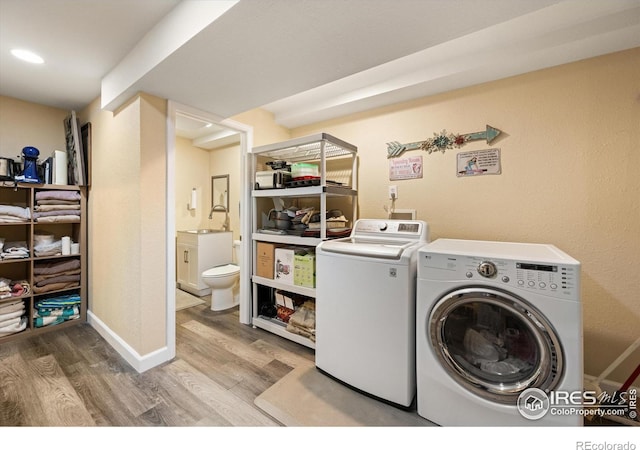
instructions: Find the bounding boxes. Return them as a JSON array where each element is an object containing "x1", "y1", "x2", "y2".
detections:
[{"x1": 251, "y1": 133, "x2": 357, "y2": 348}]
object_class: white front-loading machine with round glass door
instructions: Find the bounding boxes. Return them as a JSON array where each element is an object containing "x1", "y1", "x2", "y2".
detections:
[{"x1": 416, "y1": 239, "x2": 583, "y2": 426}]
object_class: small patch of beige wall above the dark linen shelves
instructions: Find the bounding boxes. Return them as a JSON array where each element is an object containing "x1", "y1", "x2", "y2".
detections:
[{"x1": 0, "y1": 96, "x2": 69, "y2": 161}]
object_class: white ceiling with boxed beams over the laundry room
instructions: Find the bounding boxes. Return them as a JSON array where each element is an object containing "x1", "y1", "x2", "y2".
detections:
[{"x1": 0, "y1": 0, "x2": 640, "y2": 146}]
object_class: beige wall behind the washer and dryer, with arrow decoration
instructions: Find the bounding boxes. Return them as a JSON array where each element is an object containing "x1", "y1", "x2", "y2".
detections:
[{"x1": 292, "y1": 49, "x2": 640, "y2": 382}]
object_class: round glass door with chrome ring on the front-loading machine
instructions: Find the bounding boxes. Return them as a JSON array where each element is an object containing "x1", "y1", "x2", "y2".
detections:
[{"x1": 428, "y1": 287, "x2": 564, "y2": 404}]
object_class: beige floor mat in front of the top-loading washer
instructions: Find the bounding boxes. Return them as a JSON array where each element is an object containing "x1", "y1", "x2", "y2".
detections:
[{"x1": 254, "y1": 366, "x2": 434, "y2": 427}]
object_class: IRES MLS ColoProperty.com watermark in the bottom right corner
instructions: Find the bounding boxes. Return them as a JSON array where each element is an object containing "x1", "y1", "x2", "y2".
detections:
[{"x1": 517, "y1": 388, "x2": 638, "y2": 420}]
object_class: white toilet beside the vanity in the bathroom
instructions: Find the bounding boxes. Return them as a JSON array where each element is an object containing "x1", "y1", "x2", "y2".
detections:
[{"x1": 202, "y1": 240, "x2": 240, "y2": 311}]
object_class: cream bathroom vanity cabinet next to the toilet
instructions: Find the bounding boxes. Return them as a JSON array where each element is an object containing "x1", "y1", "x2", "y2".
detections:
[{"x1": 176, "y1": 229, "x2": 233, "y2": 297}]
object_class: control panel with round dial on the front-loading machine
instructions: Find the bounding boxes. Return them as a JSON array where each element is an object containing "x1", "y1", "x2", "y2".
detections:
[{"x1": 418, "y1": 252, "x2": 580, "y2": 299}]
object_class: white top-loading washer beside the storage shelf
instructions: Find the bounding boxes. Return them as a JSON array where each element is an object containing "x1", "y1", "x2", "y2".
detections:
[{"x1": 316, "y1": 219, "x2": 429, "y2": 408}]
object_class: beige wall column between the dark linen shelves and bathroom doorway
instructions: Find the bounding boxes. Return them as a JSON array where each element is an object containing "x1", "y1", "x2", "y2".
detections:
[{"x1": 82, "y1": 96, "x2": 167, "y2": 356}]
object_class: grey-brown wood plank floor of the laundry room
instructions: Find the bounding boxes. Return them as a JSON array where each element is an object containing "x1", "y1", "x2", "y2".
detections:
[{"x1": 0, "y1": 304, "x2": 314, "y2": 427}]
